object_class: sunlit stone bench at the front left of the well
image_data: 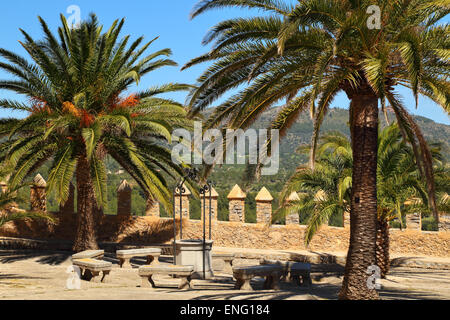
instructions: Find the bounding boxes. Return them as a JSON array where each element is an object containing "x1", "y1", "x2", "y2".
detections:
[{"x1": 139, "y1": 265, "x2": 194, "y2": 290}]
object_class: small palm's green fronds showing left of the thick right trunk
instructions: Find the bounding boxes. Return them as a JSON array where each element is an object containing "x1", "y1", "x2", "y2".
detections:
[{"x1": 274, "y1": 139, "x2": 352, "y2": 246}]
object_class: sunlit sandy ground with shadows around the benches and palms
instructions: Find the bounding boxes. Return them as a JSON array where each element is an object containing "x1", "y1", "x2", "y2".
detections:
[{"x1": 0, "y1": 251, "x2": 450, "y2": 300}]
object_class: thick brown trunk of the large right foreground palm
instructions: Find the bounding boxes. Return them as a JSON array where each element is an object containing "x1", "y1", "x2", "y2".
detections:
[{"x1": 339, "y1": 89, "x2": 378, "y2": 299}]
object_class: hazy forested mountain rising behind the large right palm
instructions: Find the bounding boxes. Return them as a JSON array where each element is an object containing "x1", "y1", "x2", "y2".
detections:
[{"x1": 208, "y1": 108, "x2": 450, "y2": 222}]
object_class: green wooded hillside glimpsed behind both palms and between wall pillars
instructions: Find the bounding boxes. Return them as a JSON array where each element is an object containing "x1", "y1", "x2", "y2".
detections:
[{"x1": 8, "y1": 108, "x2": 450, "y2": 222}]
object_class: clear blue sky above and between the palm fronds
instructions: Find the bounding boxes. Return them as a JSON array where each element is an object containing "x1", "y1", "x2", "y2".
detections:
[{"x1": 0, "y1": 0, "x2": 450, "y2": 125}]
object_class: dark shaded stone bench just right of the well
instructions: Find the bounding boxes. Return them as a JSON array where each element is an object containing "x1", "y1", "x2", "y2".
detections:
[{"x1": 233, "y1": 265, "x2": 283, "y2": 290}]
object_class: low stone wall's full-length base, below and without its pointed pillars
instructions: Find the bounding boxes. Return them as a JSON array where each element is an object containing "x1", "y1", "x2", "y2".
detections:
[{"x1": 0, "y1": 214, "x2": 450, "y2": 257}]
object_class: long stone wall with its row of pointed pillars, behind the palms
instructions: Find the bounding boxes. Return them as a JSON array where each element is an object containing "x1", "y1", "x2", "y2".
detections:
[{"x1": 0, "y1": 177, "x2": 450, "y2": 257}]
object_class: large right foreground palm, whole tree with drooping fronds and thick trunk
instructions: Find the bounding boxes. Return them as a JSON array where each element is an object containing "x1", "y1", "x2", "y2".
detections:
[{"x1": 185, "y1": 0, "x2": 450, "y2": 299}]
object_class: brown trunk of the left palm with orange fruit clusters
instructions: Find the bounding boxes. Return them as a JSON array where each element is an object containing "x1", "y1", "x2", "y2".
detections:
[{"x1": 73, "y1": 155, "x2": 98, "y2": 252}]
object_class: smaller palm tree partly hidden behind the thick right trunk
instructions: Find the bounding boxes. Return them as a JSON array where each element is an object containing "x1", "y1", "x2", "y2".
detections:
[{"x1": 277, "y1": 124, "x2": 442, "y2": 278}]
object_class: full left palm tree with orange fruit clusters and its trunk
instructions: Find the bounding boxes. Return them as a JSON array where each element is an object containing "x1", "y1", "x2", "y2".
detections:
[{"x1": 0, "y1": 15, "x2": 189, "y2": 251}]
